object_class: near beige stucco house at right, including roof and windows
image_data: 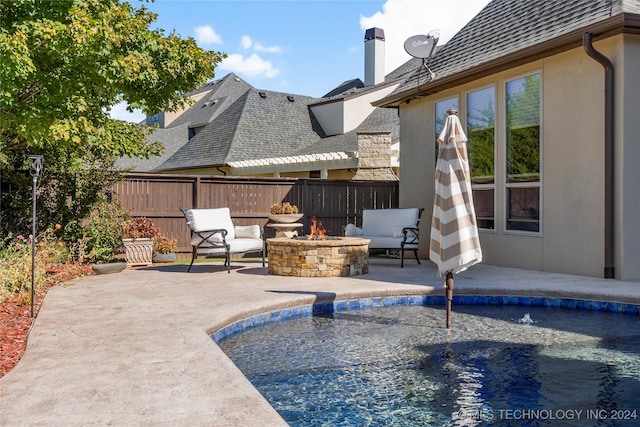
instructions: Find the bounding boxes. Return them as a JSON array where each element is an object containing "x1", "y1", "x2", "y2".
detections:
[{"x1": 373, "y1": 0, "x2": 640, "y2": 280}]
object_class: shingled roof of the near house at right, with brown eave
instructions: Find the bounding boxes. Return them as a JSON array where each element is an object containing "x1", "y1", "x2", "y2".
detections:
[{"x1": 374, "y1": 0, "x2": 640, "y2": 107}]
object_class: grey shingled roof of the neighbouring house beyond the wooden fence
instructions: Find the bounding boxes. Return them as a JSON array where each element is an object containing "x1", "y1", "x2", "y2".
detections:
[{"x1": 122, "y1": 66, "x2": 402, "y2": 172}]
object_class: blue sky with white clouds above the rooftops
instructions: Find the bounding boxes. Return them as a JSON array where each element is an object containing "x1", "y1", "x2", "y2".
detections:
[{"x1": 111, "y1": 0, "x2": 490, "y2": 122}]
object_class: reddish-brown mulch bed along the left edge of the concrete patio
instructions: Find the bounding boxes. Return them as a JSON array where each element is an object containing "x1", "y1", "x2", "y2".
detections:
[{"x1": 0, "y1": 264, "x2": 93, "y2": 378}]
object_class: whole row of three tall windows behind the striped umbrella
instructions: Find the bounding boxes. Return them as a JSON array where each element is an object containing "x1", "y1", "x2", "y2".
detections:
[{"x1": 434, "y1": 72, "x2": 542, "y2": 234}]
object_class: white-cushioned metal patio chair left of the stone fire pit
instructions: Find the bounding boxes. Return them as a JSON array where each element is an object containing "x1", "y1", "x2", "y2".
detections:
[{"x1": 181, "y1": 208, "x2": 266, "y2": 273}]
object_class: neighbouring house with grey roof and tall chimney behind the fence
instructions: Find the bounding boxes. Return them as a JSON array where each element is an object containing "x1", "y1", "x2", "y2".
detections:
[{"x1": 117, "y1": 28, "x2": 412, "y2": 180}]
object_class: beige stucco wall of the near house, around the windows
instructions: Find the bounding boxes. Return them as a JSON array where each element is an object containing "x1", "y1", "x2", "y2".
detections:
[{"x1": 400, "y1": 36, "x2": 640, "y2": 279}]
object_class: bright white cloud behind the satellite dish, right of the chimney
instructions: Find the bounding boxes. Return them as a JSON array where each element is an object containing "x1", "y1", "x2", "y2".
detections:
[{"x1": 360, "y1": 0, "x2": 490, "y2": 73}]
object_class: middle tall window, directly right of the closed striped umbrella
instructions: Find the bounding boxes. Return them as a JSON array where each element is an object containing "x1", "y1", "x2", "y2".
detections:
[{"x1": 467, "y1": 87, "x2": 496, "y2": 230}]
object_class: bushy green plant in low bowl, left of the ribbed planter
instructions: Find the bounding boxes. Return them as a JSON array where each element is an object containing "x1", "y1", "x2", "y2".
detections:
[{"x1": 84, "y1": 198, "x2": 128, "y2": 274}]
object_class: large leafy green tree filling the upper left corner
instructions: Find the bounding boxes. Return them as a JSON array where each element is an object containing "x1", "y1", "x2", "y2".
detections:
[{"x1": 0, "y1": 0, "x2": 226, "y2": 231}]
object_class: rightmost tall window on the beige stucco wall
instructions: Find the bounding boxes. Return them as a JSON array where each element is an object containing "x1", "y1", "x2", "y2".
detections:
[{"x1": 505, "y1": 74, "x2": 541, "y2": 233}]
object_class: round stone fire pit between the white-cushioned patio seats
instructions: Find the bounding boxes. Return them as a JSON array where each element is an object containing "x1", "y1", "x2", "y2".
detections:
[{"x1": 267, "y1": 237, "x2": 370, "y2": 277}]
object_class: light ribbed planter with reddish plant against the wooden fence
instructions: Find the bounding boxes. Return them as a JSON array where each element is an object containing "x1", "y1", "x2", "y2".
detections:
[{"x1": 122, "y1": 216, "x2": 160, "y2": 266}]
